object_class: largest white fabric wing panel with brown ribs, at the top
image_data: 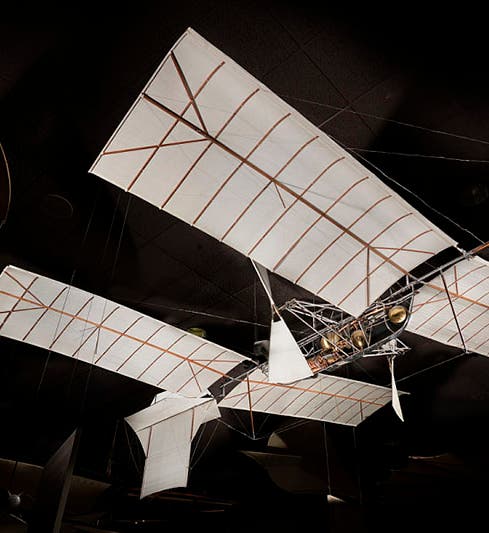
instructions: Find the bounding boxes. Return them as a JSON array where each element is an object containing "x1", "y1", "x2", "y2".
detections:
[{"x1": 91, "y1": 29, "x2": 454, "y2": 316}]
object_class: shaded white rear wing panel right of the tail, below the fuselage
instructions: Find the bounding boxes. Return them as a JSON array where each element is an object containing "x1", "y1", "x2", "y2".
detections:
[{"x1": 219, "y1": 369, "x2": 404, "y2": 426}]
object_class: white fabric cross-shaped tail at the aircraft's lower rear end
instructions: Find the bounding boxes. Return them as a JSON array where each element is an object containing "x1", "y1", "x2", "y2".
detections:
[{"x1": 126, "y1": 392, "x2": 220, "y2": 498}]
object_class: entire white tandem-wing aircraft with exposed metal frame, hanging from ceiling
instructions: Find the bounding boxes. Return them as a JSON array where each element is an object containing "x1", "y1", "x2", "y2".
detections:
[{"x1": 0, "y1": 29, "x2": 489, "y2": 497}]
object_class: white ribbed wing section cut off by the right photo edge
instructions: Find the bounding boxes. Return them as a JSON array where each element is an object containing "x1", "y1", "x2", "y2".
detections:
[{"x1": 406, "y1": 256, "x2": 489, "y2": 355}]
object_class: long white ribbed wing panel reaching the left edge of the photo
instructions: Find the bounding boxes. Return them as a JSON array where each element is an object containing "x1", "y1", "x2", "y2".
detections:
[{"x1": 0, "y1": 266, "x2": 247, "y2": 396}]
